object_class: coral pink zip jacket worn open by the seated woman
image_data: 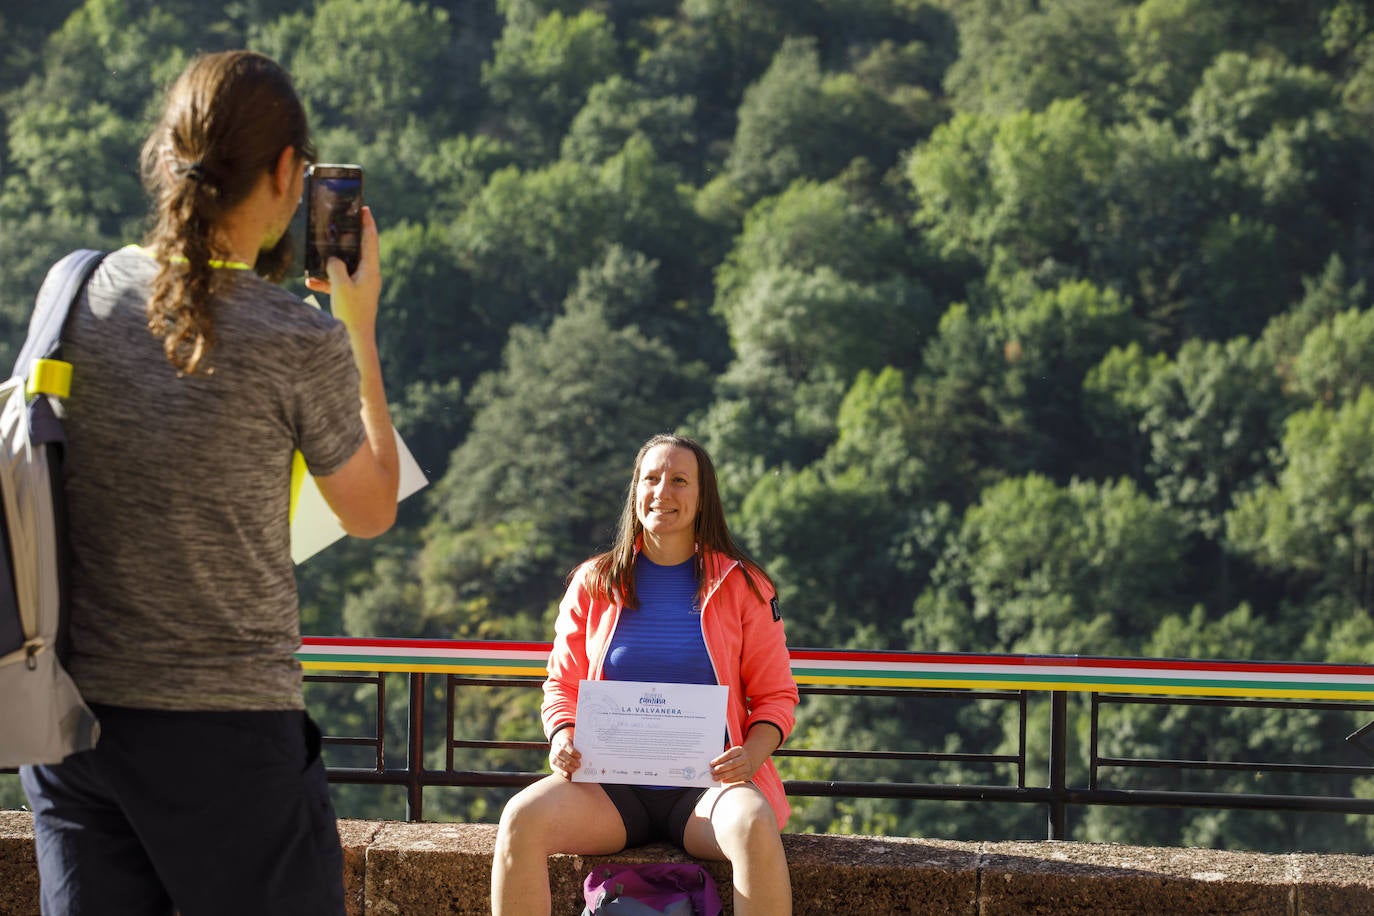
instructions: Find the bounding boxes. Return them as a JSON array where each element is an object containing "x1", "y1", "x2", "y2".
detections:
[{"x1": 543, "y1": 552, "x2": 798, "y2": 831}]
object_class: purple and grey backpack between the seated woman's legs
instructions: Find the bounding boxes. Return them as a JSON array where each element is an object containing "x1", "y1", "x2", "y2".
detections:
[{"x1": 583, "y1": 862, "x2": 721, "y2": 916}]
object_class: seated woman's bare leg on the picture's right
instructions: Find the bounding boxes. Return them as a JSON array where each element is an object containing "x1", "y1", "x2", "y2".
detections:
[{"x1": 683, "y1": 784, "x2": 791, "y2": 916}]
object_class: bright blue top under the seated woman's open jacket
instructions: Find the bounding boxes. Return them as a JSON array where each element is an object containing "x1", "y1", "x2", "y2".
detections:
[{"x1": 602, "y1": 553, "x2": 716, "y2": 684}]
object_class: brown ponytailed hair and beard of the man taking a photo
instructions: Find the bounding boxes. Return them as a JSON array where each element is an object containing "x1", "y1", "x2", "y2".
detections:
[{"x1": 142, "y1": 51, "x2": 315, "y2": 374}]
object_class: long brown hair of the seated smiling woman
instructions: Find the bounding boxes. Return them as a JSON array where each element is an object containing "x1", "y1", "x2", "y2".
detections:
[{"x1": 591, "y1": 433, "x2": 772, "y2": 607}]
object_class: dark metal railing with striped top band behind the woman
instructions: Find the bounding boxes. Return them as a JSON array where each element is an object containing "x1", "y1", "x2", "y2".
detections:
[{"x1": 298, "y1": 637, "x2": 1374, "y2": 839}]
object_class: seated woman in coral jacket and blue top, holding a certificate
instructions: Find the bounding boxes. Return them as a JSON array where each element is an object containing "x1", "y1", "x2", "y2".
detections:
[{"x1": 492, "y1": 435, "x2": 798, "y2": 916}]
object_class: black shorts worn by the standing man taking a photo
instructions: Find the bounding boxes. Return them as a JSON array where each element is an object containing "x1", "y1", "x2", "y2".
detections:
[{"x1": 19, "y1": 703, "x2": 345, "y2": 916}]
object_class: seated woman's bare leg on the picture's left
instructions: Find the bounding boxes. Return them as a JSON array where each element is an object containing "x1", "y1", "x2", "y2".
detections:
[{"x1": 492, "y1": 776, "x2": 625, "y2": 916}]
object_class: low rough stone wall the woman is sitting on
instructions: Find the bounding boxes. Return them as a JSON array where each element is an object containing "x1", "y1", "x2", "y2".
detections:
[{"x1": 0, "y1": 812, "x2": 1374, "y2": 916}]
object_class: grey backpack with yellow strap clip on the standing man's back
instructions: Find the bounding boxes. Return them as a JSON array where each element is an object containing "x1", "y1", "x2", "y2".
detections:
[{"x1": 0, "y1": 250, "x2": 104, "y2": 768}]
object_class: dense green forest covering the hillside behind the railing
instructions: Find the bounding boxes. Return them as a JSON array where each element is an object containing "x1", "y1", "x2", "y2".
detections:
[{"x1": 0, "y1": 0, "x2": 1374, "y2": 851}]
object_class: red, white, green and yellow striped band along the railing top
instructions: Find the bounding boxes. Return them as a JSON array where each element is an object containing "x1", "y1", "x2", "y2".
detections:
[{"x1": 297, "y1": 636, "x2": 1374, "y2": 700}]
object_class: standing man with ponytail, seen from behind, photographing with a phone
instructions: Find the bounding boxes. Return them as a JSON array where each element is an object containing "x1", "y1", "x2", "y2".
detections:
[{"x1": 21, "y1": 51, "x2": 398, "y2": 916}]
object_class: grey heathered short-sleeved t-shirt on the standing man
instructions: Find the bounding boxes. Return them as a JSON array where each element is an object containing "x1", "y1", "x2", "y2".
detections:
[{"x1": 63, "y1": 247, "x2": 365, "y2": 710}]
